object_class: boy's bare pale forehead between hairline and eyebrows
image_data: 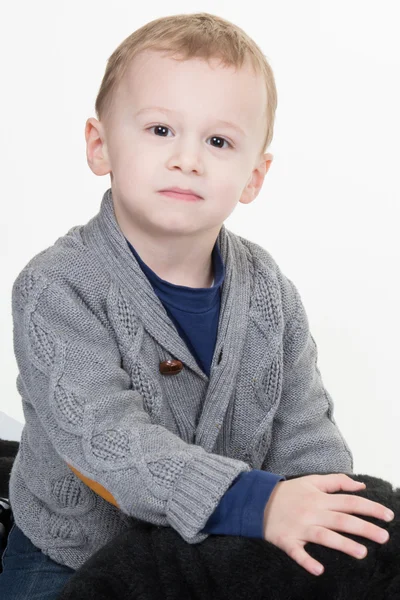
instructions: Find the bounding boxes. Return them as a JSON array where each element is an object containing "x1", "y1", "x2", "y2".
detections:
[{"x1": 116, "y1": 51, "x2": 267, "y2": 134}]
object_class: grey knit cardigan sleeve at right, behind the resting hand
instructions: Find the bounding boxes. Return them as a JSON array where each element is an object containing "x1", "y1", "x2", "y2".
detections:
[{"x1": 261, "y1": 277, "x2": 353, "y2": 476}]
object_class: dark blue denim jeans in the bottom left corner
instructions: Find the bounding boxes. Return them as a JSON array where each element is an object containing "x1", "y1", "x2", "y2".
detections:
[{"x1": 0, "y1": 523, "x2": 75, "y2": 600}]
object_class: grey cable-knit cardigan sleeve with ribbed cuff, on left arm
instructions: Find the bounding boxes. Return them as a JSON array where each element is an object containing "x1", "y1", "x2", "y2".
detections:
[{"x1": 12, "y1": 265, "x2": 250, "y2": 543}]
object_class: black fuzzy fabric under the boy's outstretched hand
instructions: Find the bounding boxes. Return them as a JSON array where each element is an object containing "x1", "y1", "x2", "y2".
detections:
[{"x1": 59, "y1": 473, "x2": 400, "y2": 600}]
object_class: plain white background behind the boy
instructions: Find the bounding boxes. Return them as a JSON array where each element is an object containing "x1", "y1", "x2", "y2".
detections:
[{"x1": 0, "y1": 0, "x2": 400, "y2": 485}]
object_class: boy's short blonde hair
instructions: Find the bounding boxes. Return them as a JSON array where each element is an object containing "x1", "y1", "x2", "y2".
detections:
[{"x1": 95, "y1": 12, "x2": 277, "y2": 153}]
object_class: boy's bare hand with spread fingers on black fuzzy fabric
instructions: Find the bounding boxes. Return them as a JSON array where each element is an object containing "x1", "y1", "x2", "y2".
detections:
[{"x1": 263, "y1": 473, "x2": 393, "y2": 575}]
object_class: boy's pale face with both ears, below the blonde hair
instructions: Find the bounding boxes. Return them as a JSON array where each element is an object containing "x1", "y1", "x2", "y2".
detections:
[{"x1": 86, "y1": 51, "x2": 272, "y2": 237}]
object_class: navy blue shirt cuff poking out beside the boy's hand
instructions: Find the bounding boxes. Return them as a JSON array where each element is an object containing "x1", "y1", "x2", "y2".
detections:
[{"x1": 203, "y1": 469, "x2": 286, "y2": 539}]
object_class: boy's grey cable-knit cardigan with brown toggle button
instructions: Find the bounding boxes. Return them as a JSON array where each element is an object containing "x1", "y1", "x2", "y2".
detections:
[{"x1": 10, "y1": 189, "x2": 352, "y2": 569}]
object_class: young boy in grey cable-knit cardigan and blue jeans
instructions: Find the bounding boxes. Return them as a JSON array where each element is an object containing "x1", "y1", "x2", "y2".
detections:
[{"x1": 0, "y1": 13, "x2": 394, "y2": 597}]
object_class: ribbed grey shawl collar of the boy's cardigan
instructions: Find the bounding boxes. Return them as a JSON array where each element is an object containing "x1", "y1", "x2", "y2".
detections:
[{"x1": 81, "y1": 188, "x2": 252, "y2": 452}]
